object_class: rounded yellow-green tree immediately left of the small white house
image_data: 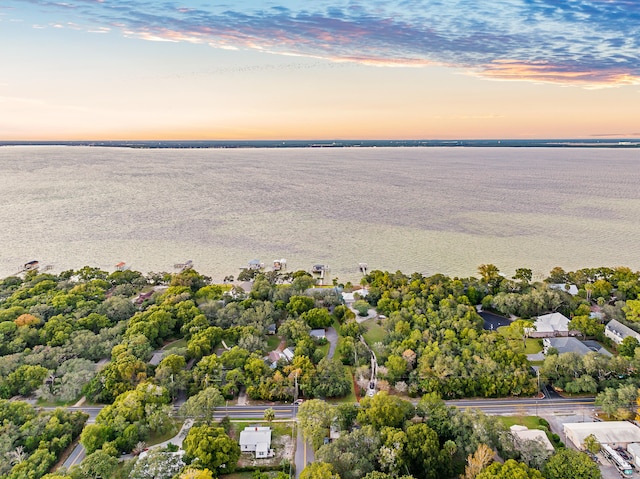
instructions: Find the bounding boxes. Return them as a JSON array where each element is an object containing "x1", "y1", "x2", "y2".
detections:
[{"x1": 182, "y1": 425, "x2": 240, "y2": 474}]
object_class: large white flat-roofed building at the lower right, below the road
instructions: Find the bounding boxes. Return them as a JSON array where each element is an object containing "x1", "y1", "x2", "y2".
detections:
[{"x1": 562, "y1": 421, "x2": 640, "y2": 449}]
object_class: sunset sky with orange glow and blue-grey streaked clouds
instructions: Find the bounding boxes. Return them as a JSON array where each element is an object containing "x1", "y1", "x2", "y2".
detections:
[{"x1": 0, "y1": 0, "x2": 640, "y2": 140}]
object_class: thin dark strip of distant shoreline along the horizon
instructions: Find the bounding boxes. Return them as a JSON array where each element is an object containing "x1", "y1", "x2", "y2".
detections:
[{"x1": 0, "y1": 138, "x2": 640, "y2": 149}]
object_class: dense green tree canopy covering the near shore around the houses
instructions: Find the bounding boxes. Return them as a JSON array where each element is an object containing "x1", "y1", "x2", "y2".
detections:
[{"x1": 0, "y1": 265, "x2": 640, "y2": 479}]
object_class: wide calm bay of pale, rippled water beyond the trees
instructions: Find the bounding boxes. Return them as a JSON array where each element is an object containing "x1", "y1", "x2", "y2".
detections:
[{"x1": 0, "y1": 146, "x2": 640, "y2": 281}]
